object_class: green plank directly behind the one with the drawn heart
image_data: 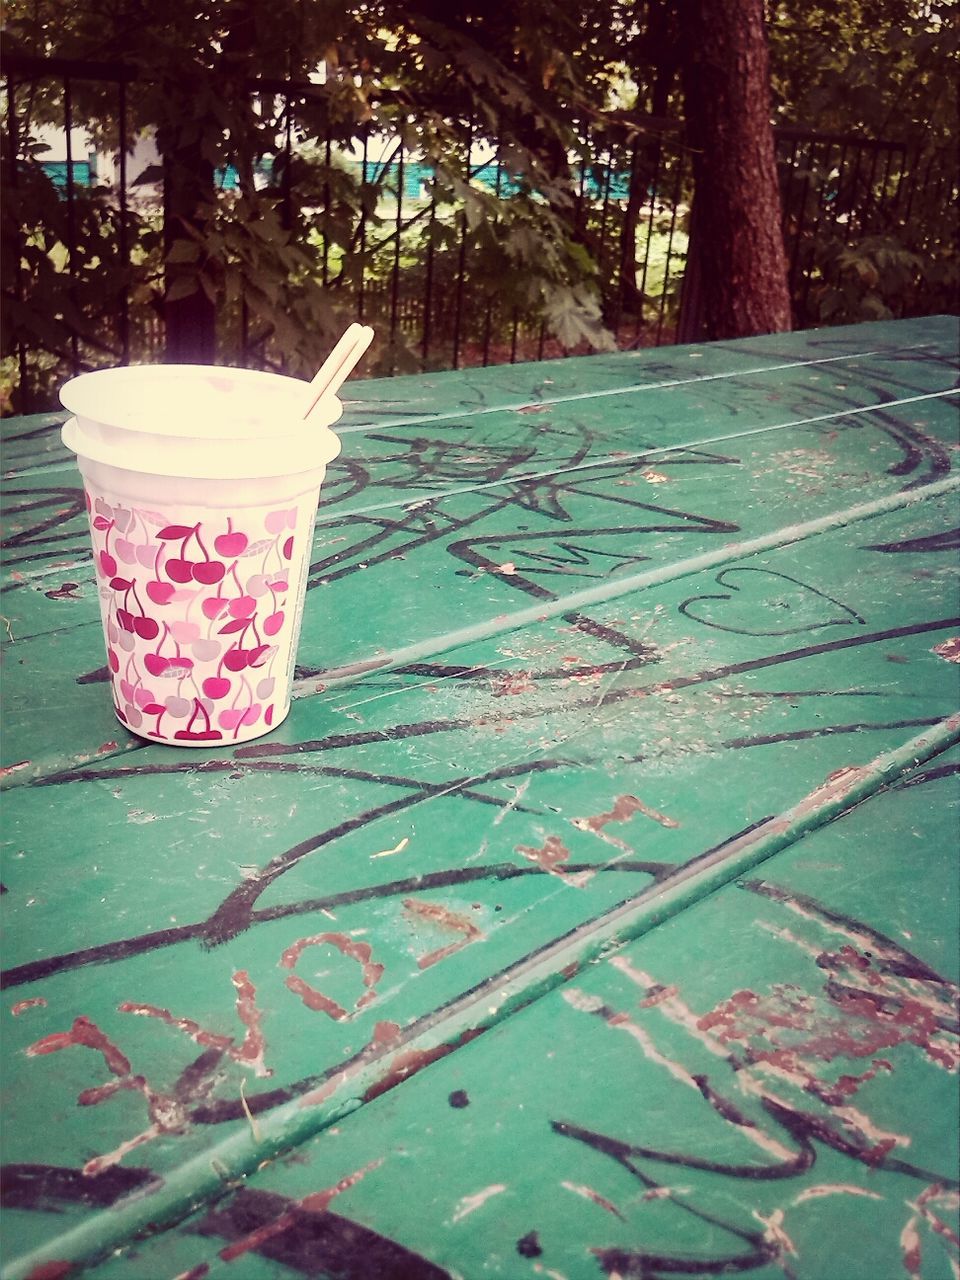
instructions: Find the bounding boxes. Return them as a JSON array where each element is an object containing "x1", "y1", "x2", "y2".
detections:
[{"x1": 3, "y1": 368, "x2": 956, "y2": 780}]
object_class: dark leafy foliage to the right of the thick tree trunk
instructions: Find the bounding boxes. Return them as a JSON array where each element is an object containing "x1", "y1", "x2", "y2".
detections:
[{"x1": 771, "y1": 0, "x2": 960, "y2": 324}]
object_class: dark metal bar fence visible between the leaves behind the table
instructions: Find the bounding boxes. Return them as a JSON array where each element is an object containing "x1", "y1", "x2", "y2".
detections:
[{"x1": 1, "y1": 56, "x2": 955, "y2": 412}]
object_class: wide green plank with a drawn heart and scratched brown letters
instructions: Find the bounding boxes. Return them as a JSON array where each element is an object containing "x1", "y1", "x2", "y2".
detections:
[{"x1": 4, "y1": 486, "x2": 957, "y2": 1274}]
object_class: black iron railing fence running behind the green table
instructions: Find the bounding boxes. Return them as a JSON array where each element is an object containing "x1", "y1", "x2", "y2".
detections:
[{"x1": 0, "y1": 55, "x2": 956, "y2": 412}]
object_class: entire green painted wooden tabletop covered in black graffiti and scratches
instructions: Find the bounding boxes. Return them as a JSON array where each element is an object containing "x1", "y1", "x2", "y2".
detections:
[{"x1": 0, "y1": 317, "x2": 960, "y2": 1280}]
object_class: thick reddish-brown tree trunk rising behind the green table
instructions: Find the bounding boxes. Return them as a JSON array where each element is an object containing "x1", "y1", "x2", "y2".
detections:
[{"x1": 681, "y1": 0, "x2": 791, "y2": 339}]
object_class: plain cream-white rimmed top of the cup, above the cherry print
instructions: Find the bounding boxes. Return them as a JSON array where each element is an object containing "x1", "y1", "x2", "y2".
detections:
[{"x1": 60, "y1": 365, "x2": 343, "y2": 480}]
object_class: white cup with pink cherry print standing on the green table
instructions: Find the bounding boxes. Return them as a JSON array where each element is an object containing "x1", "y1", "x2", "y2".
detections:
[{"x1": 60, "y1": 365, "x2": 342, "y2": 746}]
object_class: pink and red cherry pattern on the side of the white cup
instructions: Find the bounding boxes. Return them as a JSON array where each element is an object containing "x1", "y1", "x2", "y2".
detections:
[{"x1": 84, "y1": 492, "x2": 298, "y2": 744}]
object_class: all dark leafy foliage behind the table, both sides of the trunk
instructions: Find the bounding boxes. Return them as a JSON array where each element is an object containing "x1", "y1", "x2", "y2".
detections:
[{"x1": 0, "y1": 0, "x2": 957, "y2": 407}]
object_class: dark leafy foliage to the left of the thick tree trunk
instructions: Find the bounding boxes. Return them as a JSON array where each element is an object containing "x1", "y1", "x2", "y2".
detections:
[{"x1": 4, "y1": 0, "x2": 647, "y2": 404}]
